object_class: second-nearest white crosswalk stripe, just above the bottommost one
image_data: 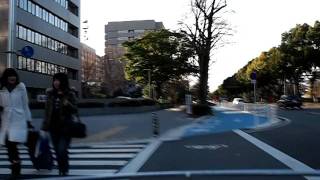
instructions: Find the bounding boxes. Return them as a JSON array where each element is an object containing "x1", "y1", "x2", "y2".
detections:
[{"x1": 0, "y1": 160, "x2": 128, "y2": 166}]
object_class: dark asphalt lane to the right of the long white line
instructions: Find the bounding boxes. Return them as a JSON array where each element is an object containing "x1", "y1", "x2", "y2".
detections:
[{"x1": 252, "y1": 109, "x2": 320, "y2": 169}]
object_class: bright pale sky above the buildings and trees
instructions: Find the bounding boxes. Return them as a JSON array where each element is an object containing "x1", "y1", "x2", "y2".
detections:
[{"x1": 81, "y1": 0, "x2": 320, "y2": 91}]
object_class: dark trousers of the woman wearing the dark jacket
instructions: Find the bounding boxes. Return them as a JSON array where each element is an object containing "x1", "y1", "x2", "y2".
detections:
[{"x1": 50, "y1": 132, "x2": 71, "y2": 172}]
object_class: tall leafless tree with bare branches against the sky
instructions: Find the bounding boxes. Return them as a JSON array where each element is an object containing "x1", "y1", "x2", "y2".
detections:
[{"x1": 180, "y1": 0, "x2": 231, "y2": 104}]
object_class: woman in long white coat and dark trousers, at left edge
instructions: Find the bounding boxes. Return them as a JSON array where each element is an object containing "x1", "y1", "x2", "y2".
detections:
[{"x1": 0, "y1": 68, "x2": 32, "y2": 179}]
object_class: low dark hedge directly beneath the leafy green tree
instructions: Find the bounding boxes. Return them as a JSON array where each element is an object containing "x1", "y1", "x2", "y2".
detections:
[{"x1": 108, "y1": 99, "x2": 156, "y2": 107}]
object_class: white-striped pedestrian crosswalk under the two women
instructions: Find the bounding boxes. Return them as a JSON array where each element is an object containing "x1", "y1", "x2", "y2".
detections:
[{"x1": 0, "y1": 142, "x2": 148, "y2": 179}]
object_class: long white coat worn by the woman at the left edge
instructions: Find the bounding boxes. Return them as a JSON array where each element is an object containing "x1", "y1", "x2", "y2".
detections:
[{"x1": 0, "y1": 83, "x2": 31, "y2": 145}]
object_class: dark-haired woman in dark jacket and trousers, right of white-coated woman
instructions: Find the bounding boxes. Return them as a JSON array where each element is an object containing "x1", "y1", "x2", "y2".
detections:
[{"x1": 41, "y1": 73, "x2": 77, "y2": 176}]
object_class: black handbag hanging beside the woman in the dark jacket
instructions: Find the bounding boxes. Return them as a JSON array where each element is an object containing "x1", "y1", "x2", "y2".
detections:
[{"x1": 69, "y1": 114, "x2": 87, "y2": 138}]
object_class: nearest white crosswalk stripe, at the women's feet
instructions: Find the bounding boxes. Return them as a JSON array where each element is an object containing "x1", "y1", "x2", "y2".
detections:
[{"x1": 0, "y1": 168, "x2": 117, "y2": 176}]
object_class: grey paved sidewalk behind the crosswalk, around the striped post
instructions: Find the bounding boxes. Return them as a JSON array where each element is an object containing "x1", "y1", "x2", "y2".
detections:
[{"x1": 33, "y1": 108, "x2": 194, "y2": 143}]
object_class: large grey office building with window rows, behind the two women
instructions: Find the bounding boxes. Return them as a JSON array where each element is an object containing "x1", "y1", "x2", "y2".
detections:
[{"x1": 0, "y1": 0, "x2": 81, "y2": 98}]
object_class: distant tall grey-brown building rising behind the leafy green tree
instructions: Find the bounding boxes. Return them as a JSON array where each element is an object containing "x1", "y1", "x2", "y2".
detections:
[{"x1": 105, "y1": 20, "x2": 164, "y2": 95}]
